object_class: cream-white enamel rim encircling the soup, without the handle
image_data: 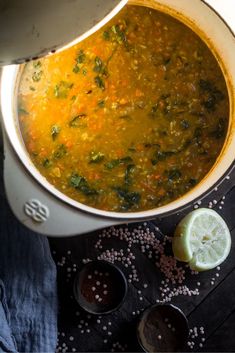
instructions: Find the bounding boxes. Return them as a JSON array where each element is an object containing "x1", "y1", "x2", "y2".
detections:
[{"x1": 1, "y1": 0, "x2": 235, "y2": 220}]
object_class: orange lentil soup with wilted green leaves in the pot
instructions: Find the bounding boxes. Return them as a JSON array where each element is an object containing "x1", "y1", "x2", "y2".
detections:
[{"x1": 18, "y1": 5, "x2": 229, "y2": 212}]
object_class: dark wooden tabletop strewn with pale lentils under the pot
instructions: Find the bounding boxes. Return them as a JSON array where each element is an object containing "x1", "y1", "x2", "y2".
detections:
[{"x1": 0, "y1": 131, "x2": 235, "y2": 352}]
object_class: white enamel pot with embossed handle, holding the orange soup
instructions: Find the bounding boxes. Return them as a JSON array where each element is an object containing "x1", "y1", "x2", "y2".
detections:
[{"x1": 1, "y1": 0, "x2": 235, "y2": 236}]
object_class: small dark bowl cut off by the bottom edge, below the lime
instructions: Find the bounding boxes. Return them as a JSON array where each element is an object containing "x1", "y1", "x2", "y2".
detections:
[{"x1": 137, "y1": 304, "x2": 189, "y2": 352}]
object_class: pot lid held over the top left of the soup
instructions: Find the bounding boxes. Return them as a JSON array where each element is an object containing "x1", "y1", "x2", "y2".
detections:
[{"x1": 0, "y1": 0, "x2": 127, "y2": 66}]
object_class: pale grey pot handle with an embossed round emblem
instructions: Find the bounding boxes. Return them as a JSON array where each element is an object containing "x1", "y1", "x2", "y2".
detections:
[{"x1": 3, "y1": 134, "x2": 123, "y2": 237}]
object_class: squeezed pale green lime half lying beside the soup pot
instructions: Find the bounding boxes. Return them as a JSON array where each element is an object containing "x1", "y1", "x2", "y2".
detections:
[{"x1": 172, "y1": 208, "x2": 231, "y2": 271}]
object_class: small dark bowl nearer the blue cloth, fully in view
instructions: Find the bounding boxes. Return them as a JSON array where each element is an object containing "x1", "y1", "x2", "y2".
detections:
[{"x1": 73, "y1": 260, "x2": 127, "y2": 315}]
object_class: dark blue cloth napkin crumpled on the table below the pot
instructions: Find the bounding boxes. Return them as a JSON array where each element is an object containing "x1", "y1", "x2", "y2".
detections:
[{"x1": 0, "y1": 220, "x2": 57, "y2": 352}]
